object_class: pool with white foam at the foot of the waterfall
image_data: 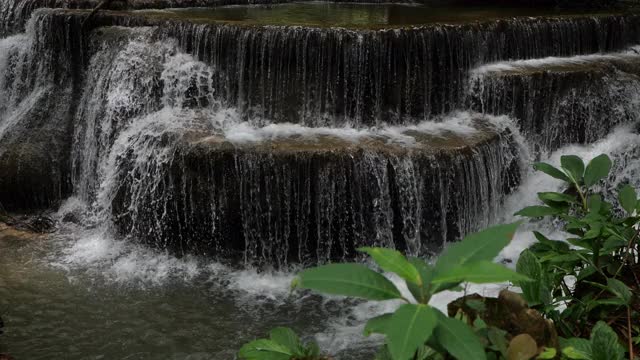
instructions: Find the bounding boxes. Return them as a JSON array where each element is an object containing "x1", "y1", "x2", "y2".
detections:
[{"x1": 0, "y1": 225, "x2": 380, "y2": 360}]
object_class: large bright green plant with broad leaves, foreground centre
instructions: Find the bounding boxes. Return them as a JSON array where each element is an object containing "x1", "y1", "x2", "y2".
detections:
[{"x1": 293, "y1": 223, "x2": 529, "y2": 360}]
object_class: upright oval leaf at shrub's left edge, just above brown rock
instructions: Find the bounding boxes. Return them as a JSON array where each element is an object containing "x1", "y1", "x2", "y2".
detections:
[{"x1": 516, "y1": 250, "x2": 551, "y2": 306}]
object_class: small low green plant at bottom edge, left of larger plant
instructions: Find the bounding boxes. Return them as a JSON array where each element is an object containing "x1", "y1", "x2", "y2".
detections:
[{"x1": 238, "y1": 327, "x2": 328, "y2": 360}]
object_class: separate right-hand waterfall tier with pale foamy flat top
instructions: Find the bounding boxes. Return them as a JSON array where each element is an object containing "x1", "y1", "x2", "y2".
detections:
[{"x1": 469, "y1": 48, "x2": 640, "y2": 152}]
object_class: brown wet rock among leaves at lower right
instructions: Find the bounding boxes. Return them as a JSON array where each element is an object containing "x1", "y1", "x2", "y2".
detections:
[{"x1": 447, "y1": 290, "x2": 559, "y2": 353}]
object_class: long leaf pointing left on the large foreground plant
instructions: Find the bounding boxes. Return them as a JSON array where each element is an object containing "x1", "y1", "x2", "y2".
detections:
[{"x1": 298, "y1": 263, "x2": 402, "y2": 300}]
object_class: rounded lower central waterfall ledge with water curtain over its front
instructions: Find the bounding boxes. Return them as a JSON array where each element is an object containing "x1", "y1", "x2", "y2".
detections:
[{"x1": 111, "y1": 115, "x2": 520, "y2": 266}]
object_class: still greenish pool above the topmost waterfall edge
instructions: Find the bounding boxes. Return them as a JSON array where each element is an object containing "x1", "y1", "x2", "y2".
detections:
[{"x1": 136, "y1": 2, "x2": 620, "y2": 28}]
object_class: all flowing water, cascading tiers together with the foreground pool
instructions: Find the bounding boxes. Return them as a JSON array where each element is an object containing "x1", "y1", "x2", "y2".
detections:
[{"x1": 0, "y1": 3, "x2": 640, "y2": 359}]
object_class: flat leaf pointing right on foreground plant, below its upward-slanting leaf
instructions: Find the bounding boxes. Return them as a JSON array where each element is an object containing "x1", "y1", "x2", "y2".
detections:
[{"x1": 432, "y1": 261, "x2": 531, "y2": 284}]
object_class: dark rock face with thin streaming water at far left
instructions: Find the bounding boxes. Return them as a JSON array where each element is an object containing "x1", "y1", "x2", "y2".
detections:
[{"x1": 0, "y1": 16, "x2": 81, "y2": 210}]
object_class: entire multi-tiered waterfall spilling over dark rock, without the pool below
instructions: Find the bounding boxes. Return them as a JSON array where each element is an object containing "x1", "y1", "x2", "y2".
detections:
[{"x1": 0, "y1": 8, "x2": 640, "y2": 267}]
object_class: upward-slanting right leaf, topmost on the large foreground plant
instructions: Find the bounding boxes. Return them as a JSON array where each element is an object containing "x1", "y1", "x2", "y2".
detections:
[{"x1": 434, "y1": 222, "x2": 520, "y2": 276}]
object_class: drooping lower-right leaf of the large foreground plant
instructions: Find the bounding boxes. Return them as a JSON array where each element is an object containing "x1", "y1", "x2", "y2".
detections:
[{"x1": 434, "y1": 312, "x2": 487, "y2": 360}]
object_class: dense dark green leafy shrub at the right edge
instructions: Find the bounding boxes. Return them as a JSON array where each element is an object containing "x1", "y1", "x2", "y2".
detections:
[{"x1": 516, "y1": 155, "x2": 640, "y2": 346}]
